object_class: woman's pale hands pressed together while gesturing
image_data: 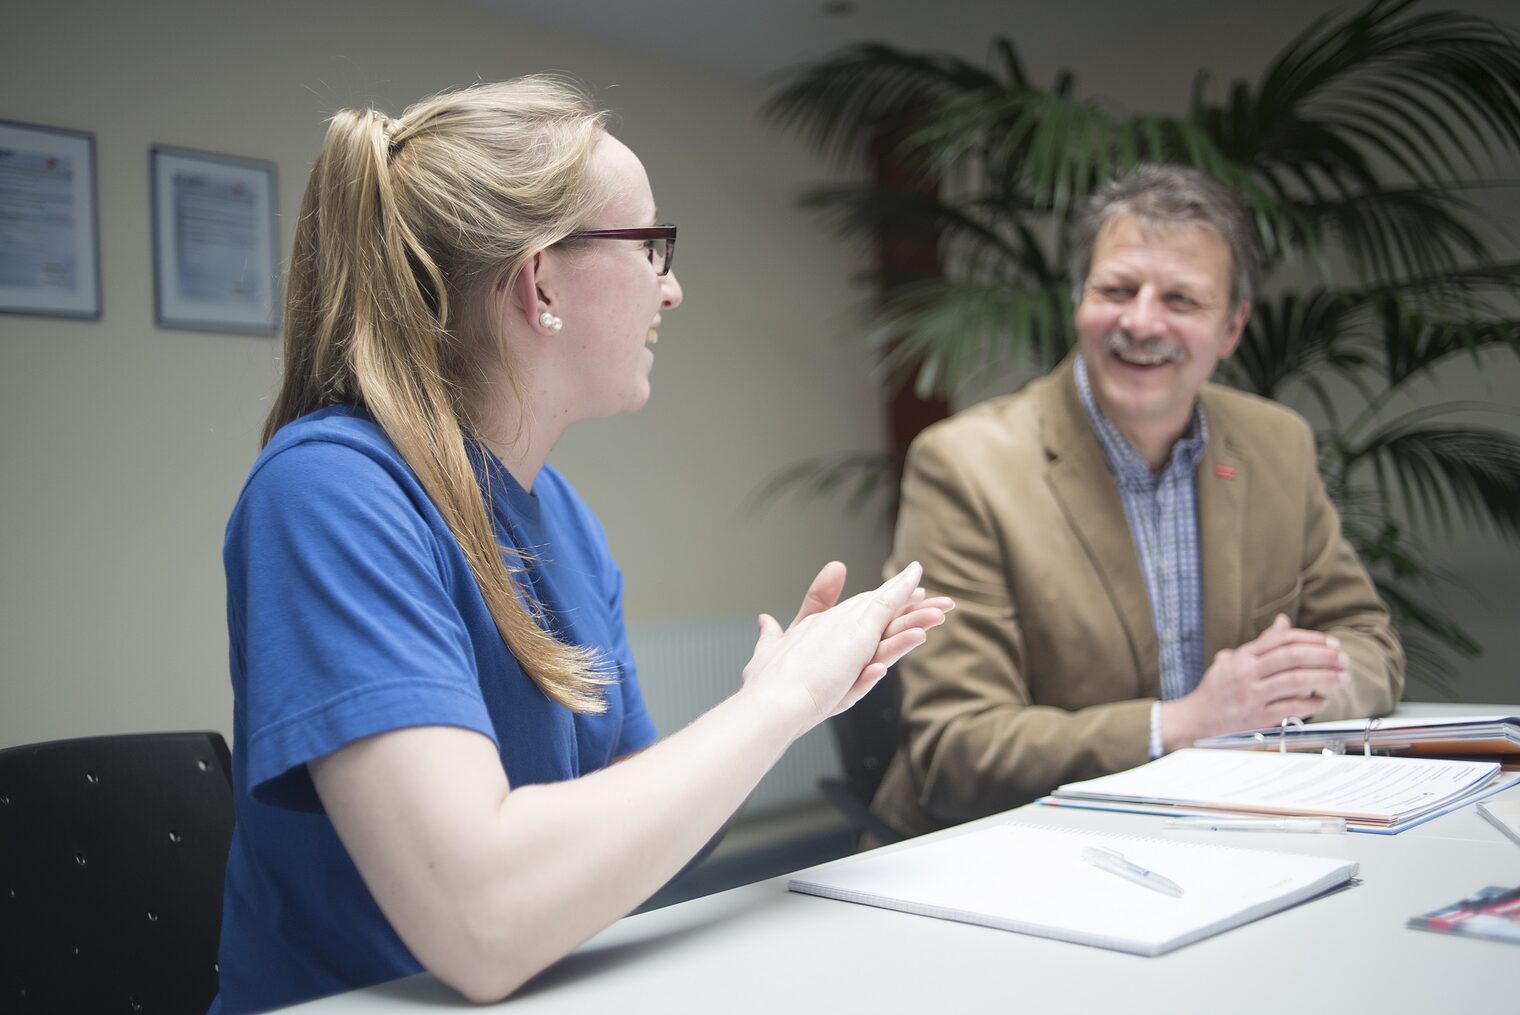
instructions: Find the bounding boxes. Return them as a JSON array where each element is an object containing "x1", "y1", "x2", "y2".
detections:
[{"x1": 745, "y1": 561, "x2": 955, "y2": 735}]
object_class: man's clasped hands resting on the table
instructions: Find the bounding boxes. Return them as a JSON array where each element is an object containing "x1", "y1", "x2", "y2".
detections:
[{"x1": 1161, "y1": 614, "x2": 1351, "y2": 751}]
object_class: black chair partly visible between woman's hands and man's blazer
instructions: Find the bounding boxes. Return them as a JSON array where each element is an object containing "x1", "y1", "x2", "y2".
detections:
[{"x1": 818, "y1": 670, "x2": 903, "y2": 845}]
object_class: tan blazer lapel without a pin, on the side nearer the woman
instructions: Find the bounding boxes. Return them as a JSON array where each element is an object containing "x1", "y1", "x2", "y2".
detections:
[{"x1": 1041, "y1": 354, "x2": 1161, "y2": 696}]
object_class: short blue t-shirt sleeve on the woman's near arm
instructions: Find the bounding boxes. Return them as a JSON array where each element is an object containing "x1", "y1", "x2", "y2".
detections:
[{"x1": 226, "y1": 442, "x2": 496, "y2": 808}]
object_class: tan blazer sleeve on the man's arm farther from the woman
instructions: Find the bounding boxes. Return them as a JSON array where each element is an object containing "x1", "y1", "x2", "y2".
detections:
[{"x1": 1295, "y1": 425, "x2": 1404, "y2": 720}]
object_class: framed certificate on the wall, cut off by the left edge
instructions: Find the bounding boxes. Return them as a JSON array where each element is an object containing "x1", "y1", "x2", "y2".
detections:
[{"x1": 0, "y1": 120, "x2": 100, "y2": 321}]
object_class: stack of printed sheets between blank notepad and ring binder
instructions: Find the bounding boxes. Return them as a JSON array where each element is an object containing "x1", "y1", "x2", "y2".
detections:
[{"x1": 1046, "y1": 749, "x2": 1514, "y2": 831}]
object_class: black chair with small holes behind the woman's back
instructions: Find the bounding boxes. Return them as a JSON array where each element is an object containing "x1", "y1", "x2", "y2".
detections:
[{"x1": 0, "y1": 732, "x2": 233, "y2": 1015}]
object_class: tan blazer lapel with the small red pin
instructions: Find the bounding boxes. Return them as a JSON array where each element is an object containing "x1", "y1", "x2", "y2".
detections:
[{"x1": 1198, "y1": 389, "x2": 1260, "y2": 669}]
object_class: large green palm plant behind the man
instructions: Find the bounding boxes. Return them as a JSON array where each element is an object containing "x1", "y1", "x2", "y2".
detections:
[{"x1": 768, "y1": 0, "x2": 1520, "y2": 691}]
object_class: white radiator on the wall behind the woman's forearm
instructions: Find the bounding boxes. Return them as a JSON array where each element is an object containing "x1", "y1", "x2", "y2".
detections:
[{"x1": 628, "y1": 617, "x2": 839, "y2": 816}]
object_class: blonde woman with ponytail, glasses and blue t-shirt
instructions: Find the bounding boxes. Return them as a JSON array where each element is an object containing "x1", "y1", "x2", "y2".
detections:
[{"x1": 213, "y1": 77, "x2": 950, "y2": 1013}]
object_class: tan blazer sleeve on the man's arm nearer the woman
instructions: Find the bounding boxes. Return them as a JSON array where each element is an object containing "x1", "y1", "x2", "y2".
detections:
[{"x1": 877, "y1": 430, "x2": 1154, "y2": 834}]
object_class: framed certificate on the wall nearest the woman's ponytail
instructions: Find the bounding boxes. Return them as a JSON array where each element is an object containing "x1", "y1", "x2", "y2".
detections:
[{"x1": 149, "y1": 144, "x2": 280, "y2": 336}]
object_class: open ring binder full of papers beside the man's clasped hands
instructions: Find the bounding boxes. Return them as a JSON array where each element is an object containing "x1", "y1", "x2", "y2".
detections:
[{"x1": 1193, "y1": 716, "x2": 1520, "y2": 757}]
